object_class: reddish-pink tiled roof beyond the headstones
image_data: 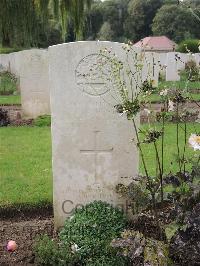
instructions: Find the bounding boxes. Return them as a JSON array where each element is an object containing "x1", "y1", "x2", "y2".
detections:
[{"x1": 134, "y1": 36, "x2": 176, "y2": 50}]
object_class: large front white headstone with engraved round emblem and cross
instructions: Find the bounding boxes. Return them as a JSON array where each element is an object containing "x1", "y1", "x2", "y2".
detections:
[{"x1": 49, "y1": 42, "x2": 141, "y2": 227}]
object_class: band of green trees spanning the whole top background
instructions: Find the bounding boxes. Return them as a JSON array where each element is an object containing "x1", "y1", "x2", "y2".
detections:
[{"x1": 0, "y1": 0, "x2": 200, "y2": 47}]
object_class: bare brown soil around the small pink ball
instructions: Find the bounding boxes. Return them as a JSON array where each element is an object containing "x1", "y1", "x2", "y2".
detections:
[{"x1": 0, "y1": 209, "x2": 55, "y2": 266}]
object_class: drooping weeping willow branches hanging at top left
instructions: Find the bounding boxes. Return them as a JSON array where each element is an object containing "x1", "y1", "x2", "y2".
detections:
[{"x1": 0, "y1": 0, "x2": 92, "y2": 46}]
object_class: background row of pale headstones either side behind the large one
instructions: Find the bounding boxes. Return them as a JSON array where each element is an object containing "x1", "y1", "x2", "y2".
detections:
[{"x1": 0, "y1": 46, "x2": 200, "y2": 118}]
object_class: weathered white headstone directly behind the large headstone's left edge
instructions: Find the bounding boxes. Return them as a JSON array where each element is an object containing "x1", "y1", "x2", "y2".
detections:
[{"x1": 19, "y1": 49, "x2": 50, "y2": 118}]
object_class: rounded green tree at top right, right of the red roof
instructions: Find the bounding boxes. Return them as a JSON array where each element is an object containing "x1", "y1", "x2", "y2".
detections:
[{"x1": 152, "y1": 4, "x2": 200, "y2": 42}]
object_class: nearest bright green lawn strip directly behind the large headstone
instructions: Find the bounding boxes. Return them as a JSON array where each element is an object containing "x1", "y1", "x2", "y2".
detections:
[{"x1": 0, "y1": 124, "x2": 200, "y2": 209}]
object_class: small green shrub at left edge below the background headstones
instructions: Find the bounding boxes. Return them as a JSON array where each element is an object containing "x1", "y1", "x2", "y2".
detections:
[{"x1": 0, "y1": 71, "x2": 18, "y2": 95}]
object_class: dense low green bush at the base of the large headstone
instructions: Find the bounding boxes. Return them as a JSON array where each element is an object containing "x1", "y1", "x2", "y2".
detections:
[{"x1": 60, "y1": 201, "x2": 126, "y2": 265}]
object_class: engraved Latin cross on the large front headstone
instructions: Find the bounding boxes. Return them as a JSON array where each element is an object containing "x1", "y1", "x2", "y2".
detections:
[{"x1": 80, "y1": 130, "x2": 113, "y2": 183}]
